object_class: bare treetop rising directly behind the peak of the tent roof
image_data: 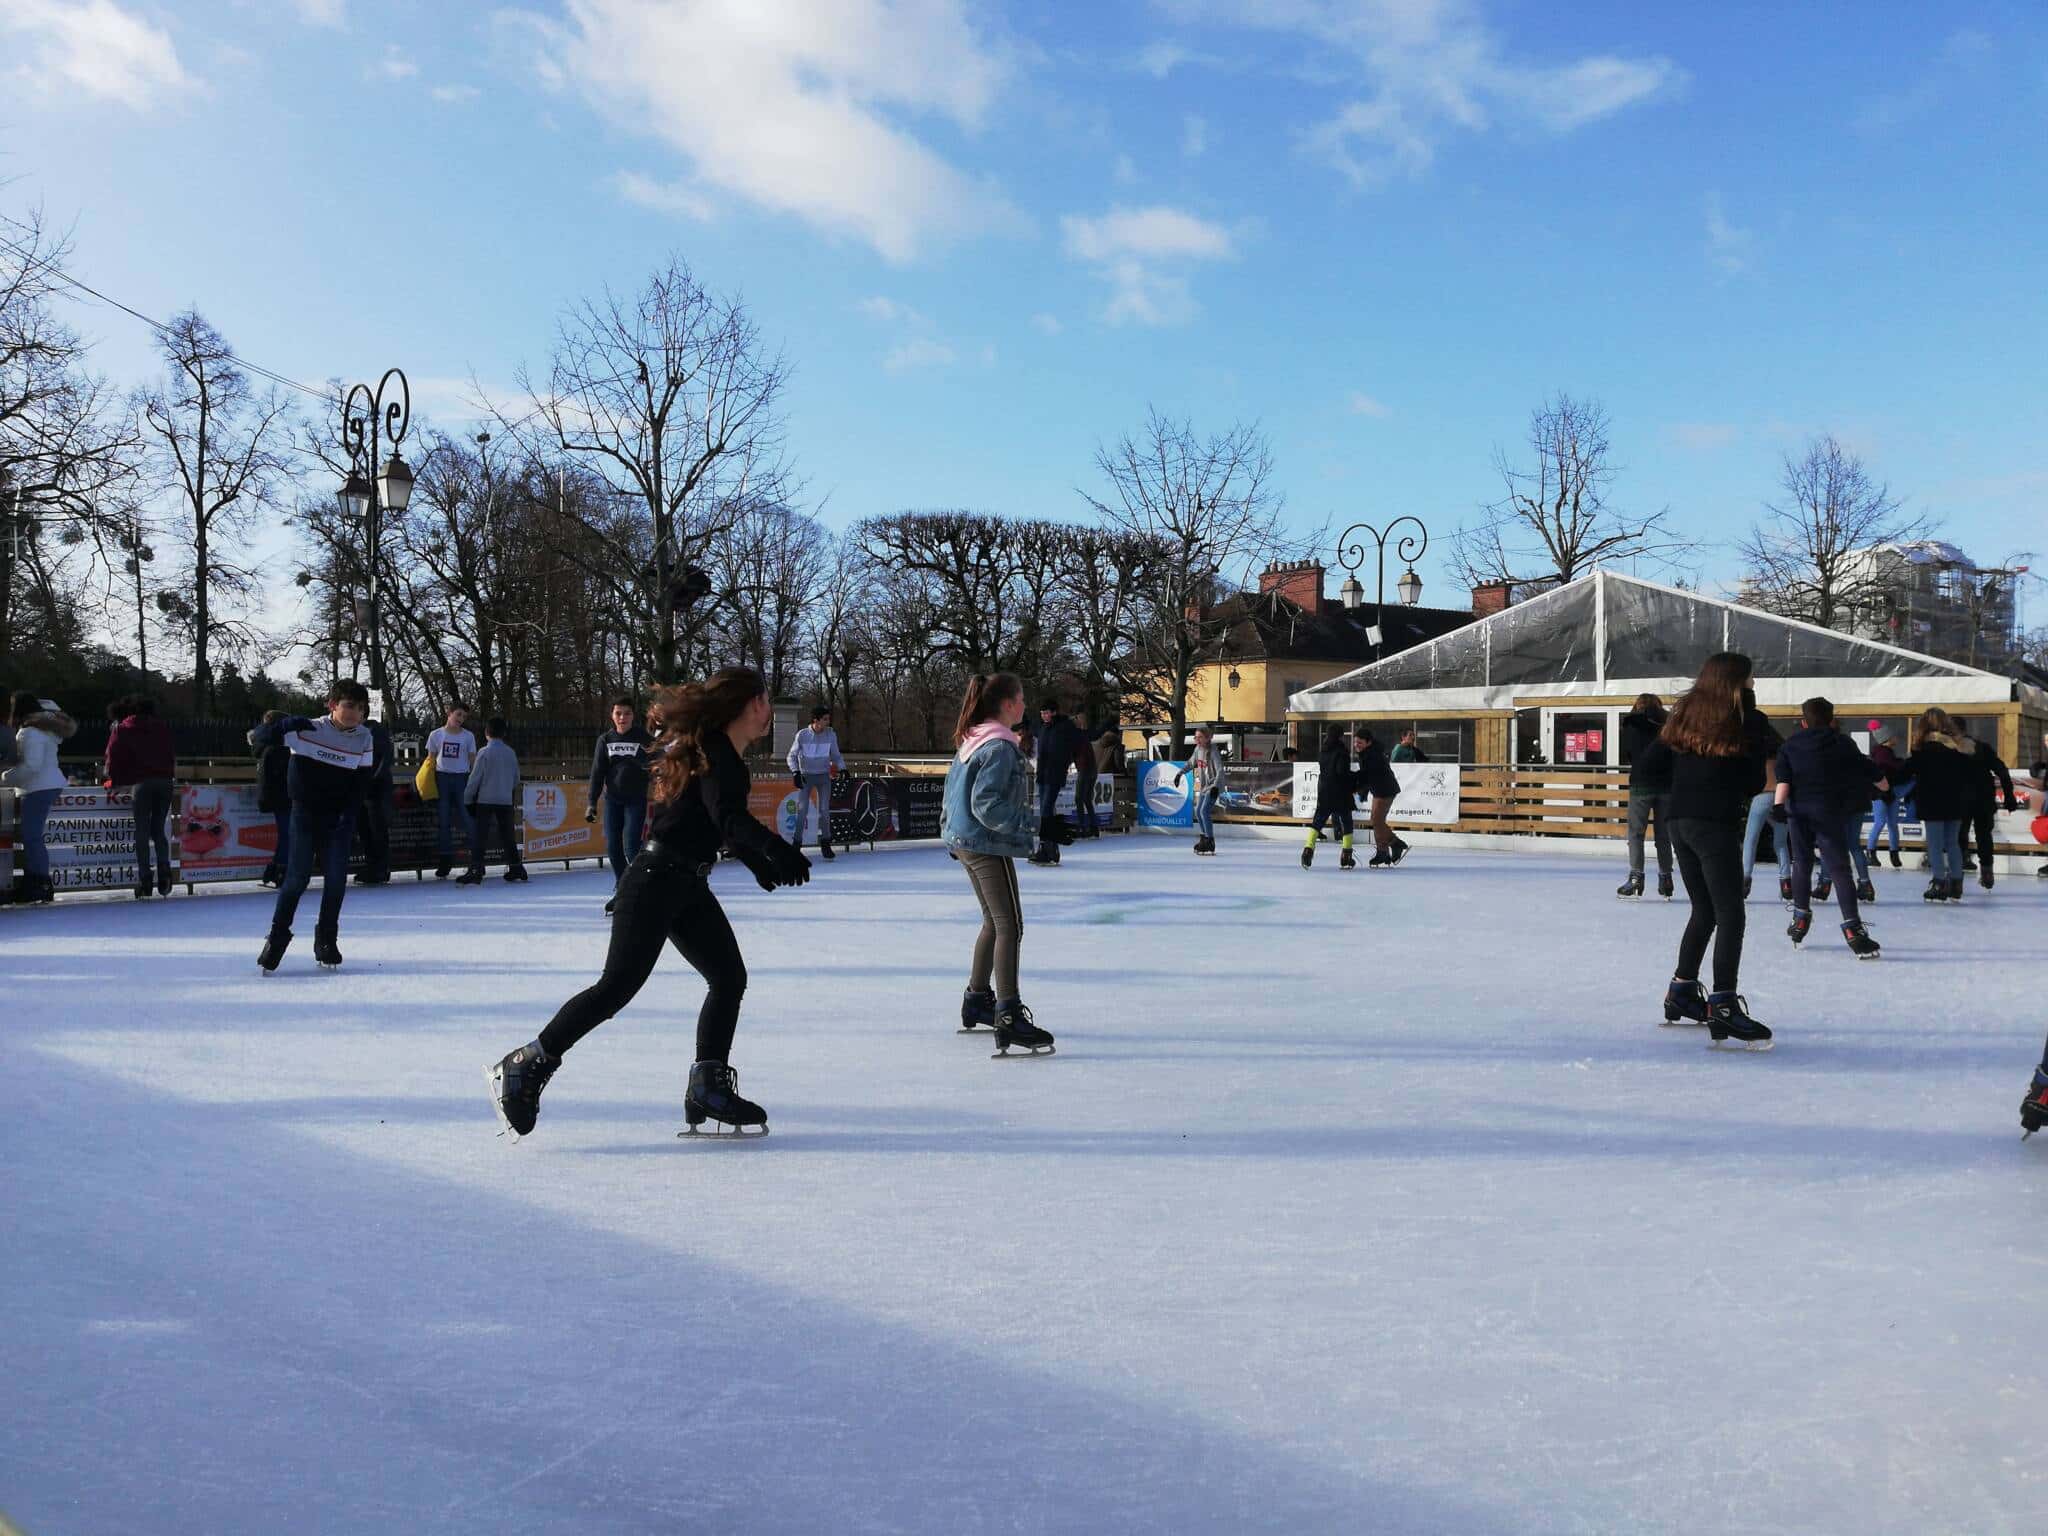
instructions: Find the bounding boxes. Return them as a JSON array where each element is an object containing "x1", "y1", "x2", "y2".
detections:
[{"x1": 1452, "y1": 393, "x2": 1694, "y2": 586}]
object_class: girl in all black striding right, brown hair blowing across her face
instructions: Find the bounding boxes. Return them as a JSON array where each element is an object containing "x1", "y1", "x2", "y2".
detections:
[{"x1": 487, "y1": 668, "x2": 811, "y2": 1139}]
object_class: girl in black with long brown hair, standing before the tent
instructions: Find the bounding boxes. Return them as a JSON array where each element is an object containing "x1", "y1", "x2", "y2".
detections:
[{"x1": 1645, "y1": 651, "x2": 1778, "y2": 1051}]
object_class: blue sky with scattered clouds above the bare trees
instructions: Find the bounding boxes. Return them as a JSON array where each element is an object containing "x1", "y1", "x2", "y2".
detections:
[{"x1": 0, "y1": 0, "x2": 2048, "y2": 618}]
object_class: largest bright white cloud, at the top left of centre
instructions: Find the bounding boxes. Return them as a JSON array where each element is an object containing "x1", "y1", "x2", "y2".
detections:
[{"x1": 500, "y1": 0, "x2": 1026, "y2": 262}]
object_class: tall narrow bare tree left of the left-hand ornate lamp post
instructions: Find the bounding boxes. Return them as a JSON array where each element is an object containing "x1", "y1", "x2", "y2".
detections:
[{"x1": 137, "y1": 309, "x2": 291, "y2": 715}]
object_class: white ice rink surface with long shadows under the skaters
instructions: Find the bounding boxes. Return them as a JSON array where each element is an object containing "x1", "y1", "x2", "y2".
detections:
[{"x1": 0, "y1": 838, "x2": 2048, "y2": 1536}]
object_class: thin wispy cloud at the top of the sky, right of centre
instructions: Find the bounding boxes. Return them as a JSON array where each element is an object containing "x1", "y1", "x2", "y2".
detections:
[{"x1": 1163, "y1": 0, "x2": 1683, "y2": 186}]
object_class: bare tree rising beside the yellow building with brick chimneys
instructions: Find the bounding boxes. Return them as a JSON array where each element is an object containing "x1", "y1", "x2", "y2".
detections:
[{"x1": 1083, "y1": 410, "x2": 1284, "y2": 754}]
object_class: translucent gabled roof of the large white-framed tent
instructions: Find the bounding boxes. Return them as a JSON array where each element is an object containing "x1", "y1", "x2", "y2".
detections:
[{"x1": 1288, "y1": 569, "x2": 2023, "y2": 717}]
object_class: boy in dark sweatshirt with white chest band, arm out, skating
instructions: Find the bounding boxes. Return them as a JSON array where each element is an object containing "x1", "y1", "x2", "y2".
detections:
[{"x1": 254, "y1": 678, "x2": 377, "y2": 975}]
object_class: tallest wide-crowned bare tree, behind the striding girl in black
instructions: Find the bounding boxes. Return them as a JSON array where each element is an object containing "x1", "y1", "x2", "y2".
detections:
[{"x1": 512, "y1": 256, "x2": 791, "y2": 678}]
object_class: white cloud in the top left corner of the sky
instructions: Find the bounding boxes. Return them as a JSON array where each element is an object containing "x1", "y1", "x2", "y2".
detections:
[{"x1": 0, "y1": 0, "x2": 199, "y2": 113}]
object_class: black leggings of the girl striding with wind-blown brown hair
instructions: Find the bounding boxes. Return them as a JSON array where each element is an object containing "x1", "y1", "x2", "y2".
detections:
[{"x1": 541, "y1": 852, "x2": 748, "y2": 1061}]
